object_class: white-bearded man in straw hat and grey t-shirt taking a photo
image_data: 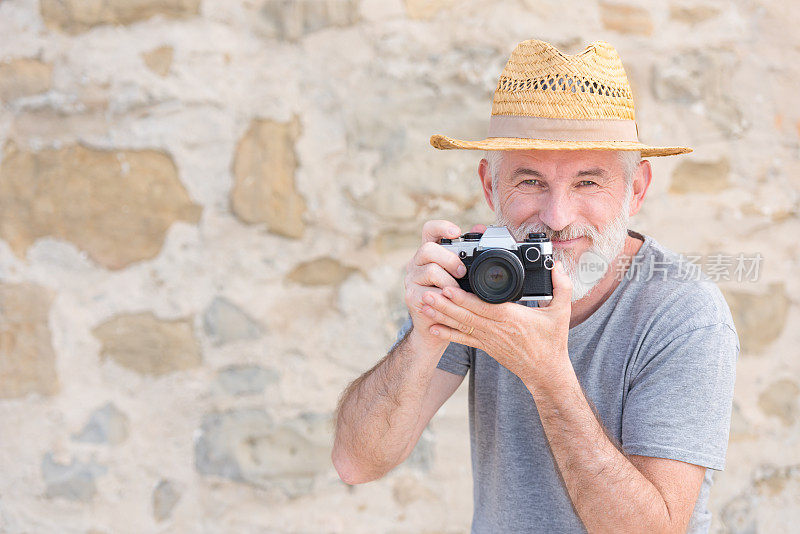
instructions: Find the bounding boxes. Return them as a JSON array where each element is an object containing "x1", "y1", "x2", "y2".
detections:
[{"x1": 332, "y1": 41, "x2": 739, "y2": 533}]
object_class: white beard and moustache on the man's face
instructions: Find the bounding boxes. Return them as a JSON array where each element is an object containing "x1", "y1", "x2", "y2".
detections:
[{"x1": 494, "y1": 195, "x2": 630, "y2": 302}]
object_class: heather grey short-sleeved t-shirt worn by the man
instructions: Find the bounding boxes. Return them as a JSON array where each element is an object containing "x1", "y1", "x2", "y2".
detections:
[{"x1": 397, "y1": 231, "x2": 739, "y2": 533}]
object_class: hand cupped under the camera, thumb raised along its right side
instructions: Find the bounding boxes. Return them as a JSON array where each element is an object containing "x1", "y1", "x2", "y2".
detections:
[{"x1": 423, "y1": 261, "x2": 572, "y2": 386}]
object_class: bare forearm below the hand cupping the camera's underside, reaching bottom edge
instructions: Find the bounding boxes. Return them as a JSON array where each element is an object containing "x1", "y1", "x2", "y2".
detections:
[{"x1": 528, "y1": 365, "x2": 671, "y2": 533}]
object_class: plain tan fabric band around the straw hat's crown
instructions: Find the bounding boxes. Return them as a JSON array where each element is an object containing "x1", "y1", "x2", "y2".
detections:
[{"x1": 488, "y1": 115, "x2": 639, "y2": 143}]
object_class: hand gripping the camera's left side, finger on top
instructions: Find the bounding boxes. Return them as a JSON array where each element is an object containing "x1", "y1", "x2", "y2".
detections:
[{"x1": 405, "y1": 220, "x2": 486, "y2": 348}]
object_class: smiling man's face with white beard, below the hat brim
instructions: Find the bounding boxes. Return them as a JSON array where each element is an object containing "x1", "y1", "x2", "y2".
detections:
[{"x1": 484, "y1": 150, "x2": 630, "y2": 301}]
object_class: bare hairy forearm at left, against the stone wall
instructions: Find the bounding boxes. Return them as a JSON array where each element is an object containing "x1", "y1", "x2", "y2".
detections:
[{"x1": 332, "y1": 329, "x2": 447, "y2": 484}]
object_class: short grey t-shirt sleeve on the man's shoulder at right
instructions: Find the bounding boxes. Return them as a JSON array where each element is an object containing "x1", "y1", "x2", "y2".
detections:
[{"x1": 622, "y1": 323, "x2": 739, "y2": 471}]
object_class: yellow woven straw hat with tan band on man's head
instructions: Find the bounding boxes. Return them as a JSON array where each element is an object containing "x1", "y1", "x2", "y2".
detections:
[{"x1": 431, "y1": 39, "x2": 692, "y2": 157}]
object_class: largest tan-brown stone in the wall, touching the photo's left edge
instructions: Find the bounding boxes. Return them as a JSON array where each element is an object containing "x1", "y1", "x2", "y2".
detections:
[{"x1": 0, "y1": 143, "x2": 202, "y2": 269}]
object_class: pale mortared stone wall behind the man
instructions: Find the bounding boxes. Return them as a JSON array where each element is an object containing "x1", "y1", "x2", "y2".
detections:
[{"x1": 0, "y1": 0, "x2": 800, "y2": 533}]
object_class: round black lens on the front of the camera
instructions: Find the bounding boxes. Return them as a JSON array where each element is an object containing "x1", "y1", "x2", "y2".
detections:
[{"x1": 469, "y1": 249, "x2": 525, "y2": 304}]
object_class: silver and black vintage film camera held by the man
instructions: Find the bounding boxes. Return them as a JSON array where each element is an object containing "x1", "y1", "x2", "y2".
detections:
[{"x1": 439, "y1": 226, "x2": 554, "y2": 304}]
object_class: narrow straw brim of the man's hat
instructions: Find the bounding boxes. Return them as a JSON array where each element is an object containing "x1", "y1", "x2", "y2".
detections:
[{"x1": 431, "y1": 134, "x2": 692, "y2": 158}]
